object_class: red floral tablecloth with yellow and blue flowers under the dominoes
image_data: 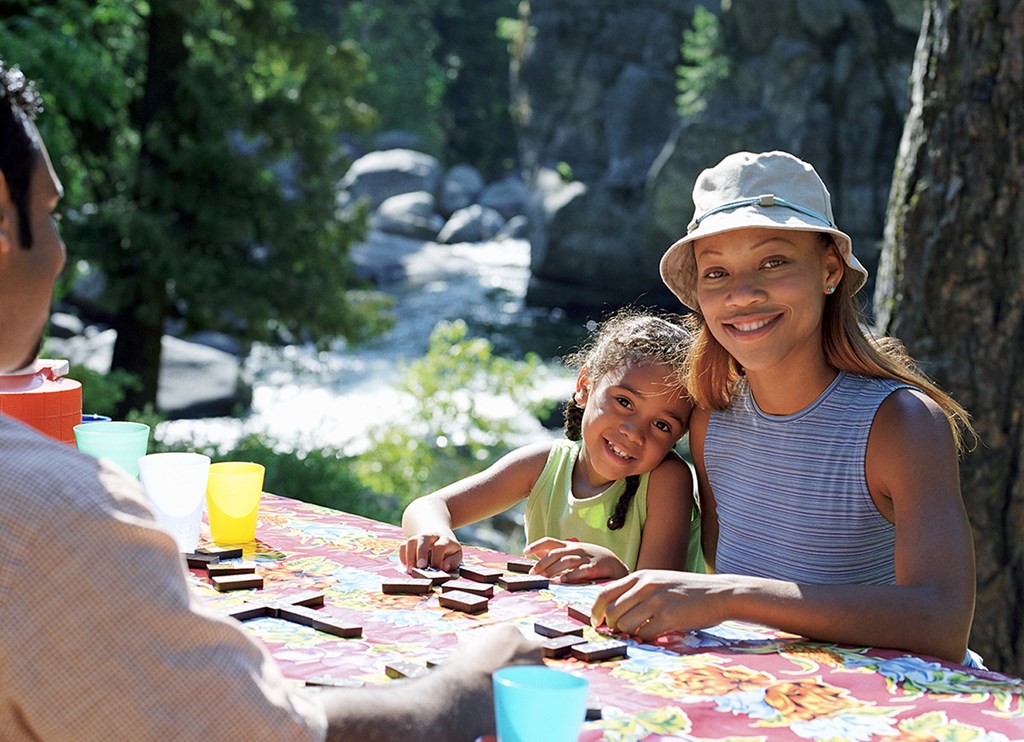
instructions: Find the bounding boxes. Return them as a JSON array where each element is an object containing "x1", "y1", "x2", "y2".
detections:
[{"x1": 191, "y1": 494, "x2": 1024, "y2": 742}]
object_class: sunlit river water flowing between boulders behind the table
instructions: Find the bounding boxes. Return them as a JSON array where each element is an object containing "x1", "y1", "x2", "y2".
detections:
[{"x1": 158, "y1": 233, "x2": 583, "y2": 453}]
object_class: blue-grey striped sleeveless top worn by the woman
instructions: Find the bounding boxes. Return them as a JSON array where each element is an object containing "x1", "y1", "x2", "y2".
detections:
[{"x1": 705, "y1": 372, "x2": 908, "y2": 584}]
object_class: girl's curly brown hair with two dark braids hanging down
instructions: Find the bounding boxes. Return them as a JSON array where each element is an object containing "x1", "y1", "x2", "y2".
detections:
[{"x1": 563, "y1": 307, "x2": 692, "y2": 531}]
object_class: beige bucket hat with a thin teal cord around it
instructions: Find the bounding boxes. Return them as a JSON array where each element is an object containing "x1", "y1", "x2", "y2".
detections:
[{"x1": 660, "y1": 151, "x2": 867, "y2": 309}]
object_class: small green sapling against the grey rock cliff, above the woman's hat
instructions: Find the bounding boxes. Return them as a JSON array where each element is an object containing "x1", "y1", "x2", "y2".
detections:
[{"x1": 676, "y1": 5, "x2": 731, "y2": 117}]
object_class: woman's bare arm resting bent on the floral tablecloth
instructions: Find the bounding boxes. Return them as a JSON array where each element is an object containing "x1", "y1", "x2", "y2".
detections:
[{"x1": 594, "y1": 391, "x2": 975, "y2": 662}]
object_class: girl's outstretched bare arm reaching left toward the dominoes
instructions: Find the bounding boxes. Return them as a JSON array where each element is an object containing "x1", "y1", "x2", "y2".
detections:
[{"x1": 398, "y1": 442, "x2": 551, "y2": 572}]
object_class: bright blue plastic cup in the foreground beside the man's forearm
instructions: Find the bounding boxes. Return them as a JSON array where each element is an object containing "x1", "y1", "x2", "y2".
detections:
[{"x1": 492, "y1": 664, "x2": 590, "y2": 742}]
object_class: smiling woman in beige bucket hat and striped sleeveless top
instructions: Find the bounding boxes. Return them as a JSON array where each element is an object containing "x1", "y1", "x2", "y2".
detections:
[{"x1": 594, "y1": 151, "x2": 975, "y2": 662}]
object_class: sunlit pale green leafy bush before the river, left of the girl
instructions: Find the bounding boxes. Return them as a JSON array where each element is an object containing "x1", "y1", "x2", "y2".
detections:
[{"x1": 355, "y1": 319, "x2": 542, "y2": 504}]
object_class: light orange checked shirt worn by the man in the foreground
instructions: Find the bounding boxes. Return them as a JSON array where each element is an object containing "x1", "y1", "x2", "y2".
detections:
[{"x1": 0, "y1": 417, "x2": 327, "y2": 741}]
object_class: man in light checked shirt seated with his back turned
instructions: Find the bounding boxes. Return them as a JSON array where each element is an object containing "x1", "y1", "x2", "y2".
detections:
[{"x1": 0, "y1": 60, "x2": 541, "y2": 742}]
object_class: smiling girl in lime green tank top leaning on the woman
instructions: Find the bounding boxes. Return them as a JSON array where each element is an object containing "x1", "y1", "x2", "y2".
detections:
[{"x1": 399, "y1": 310, "x2": 702, "y2": 581}]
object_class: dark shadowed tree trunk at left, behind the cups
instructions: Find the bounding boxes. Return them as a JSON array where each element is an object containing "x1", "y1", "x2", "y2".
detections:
[{"x1": 111, "y1": 0, "x2": 194, "y2": 417}]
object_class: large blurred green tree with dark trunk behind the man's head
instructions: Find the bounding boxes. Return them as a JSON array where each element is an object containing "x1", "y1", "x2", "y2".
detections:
[{"x1": 0, "y1": 0, "x2": 382, "y2": 411}]
